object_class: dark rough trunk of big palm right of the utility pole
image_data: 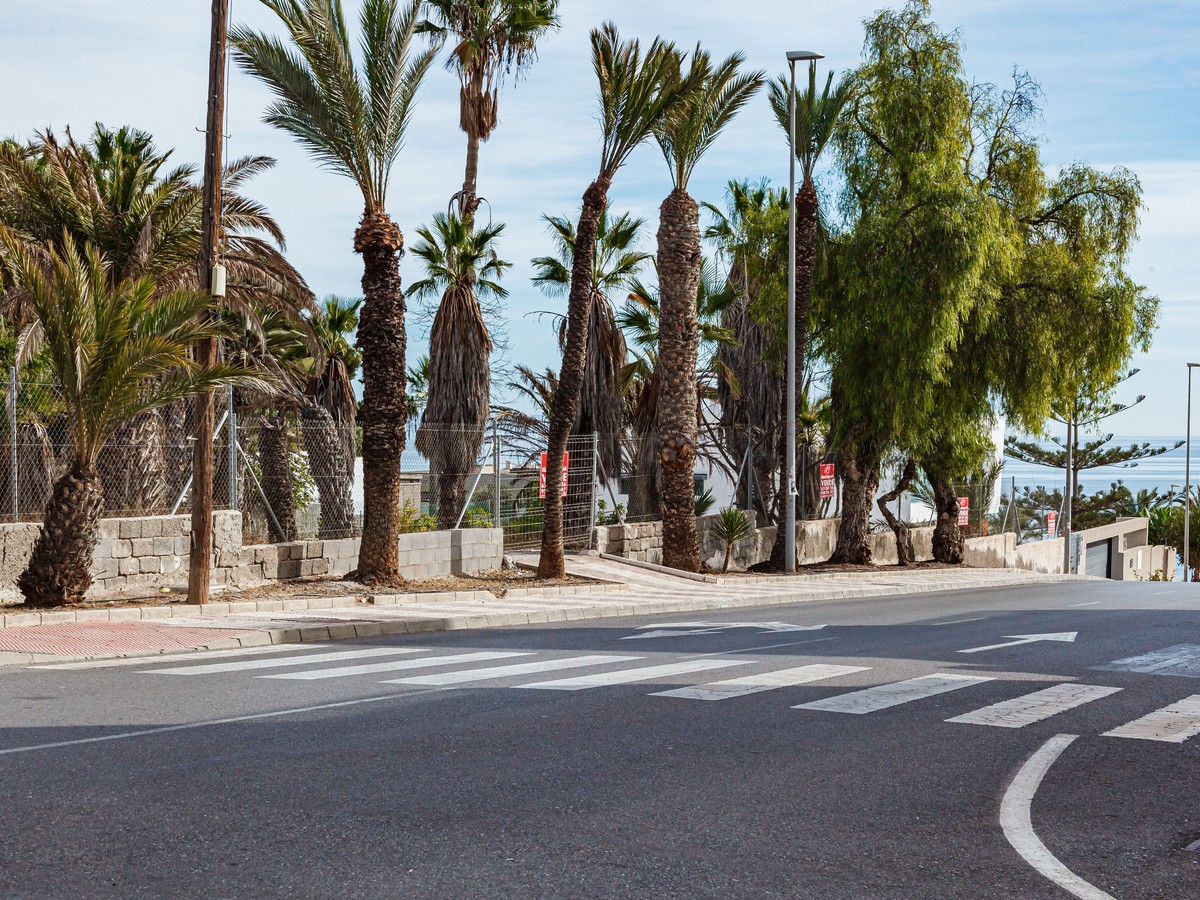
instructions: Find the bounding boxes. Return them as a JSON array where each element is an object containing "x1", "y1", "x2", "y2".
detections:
[{"x1": 352, "y1": 209, "x2": 408, "y2": 584}]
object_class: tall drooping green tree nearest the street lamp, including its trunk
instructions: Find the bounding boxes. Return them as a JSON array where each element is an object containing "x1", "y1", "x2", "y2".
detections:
[{"x1": 823, "y1": 0, "x2": 1003, "y2": 563}]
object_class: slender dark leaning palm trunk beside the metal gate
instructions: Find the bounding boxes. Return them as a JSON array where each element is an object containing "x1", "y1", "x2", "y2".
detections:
[{"x1": 538, "y1": 176, "x2": 610, "y2": 578}]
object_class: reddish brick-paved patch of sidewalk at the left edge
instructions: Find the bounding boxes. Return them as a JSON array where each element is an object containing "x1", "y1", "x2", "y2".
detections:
[{"x1": 0, "y1": 622, "x2": 250, "y2": 656}]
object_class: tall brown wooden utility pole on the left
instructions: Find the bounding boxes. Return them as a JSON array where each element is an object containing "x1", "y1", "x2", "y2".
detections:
[{"x1": 187, "y1": 0, "x2": 229, "y2": 604}]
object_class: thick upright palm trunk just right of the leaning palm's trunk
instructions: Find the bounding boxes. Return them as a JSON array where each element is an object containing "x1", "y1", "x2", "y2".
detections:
[{"x1": 658, "y1": 188, "x2": 701, "y2": 572}]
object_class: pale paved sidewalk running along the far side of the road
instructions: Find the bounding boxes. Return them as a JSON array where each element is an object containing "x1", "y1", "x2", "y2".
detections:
[{"x1": 0, "y1": 557, "x2": 1078, "y2": 666}]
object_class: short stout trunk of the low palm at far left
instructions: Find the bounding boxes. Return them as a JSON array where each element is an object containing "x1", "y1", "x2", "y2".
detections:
[{"x1": 17, "y1": 461, "x2": 104, "y2": 607}]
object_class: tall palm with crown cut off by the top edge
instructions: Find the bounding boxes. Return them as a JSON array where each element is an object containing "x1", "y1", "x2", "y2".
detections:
[{"x1": 420, "y1": 0, "x2": 558, "y2": 224}]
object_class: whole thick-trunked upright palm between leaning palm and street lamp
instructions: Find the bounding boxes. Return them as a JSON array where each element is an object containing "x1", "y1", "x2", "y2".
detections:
[{"x1": 654, "y1": 47, "x2": 766, "y2": 572}]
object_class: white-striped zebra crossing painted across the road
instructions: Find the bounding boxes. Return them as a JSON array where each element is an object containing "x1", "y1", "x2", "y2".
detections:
[{"x1": 36, "y1": 644, "x2": 1200, "y2": 744}]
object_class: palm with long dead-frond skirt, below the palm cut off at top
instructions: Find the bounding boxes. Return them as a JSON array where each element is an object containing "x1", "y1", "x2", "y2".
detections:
[{"x1": 409, "y1": 212, "x2": 512, "y2": 528}]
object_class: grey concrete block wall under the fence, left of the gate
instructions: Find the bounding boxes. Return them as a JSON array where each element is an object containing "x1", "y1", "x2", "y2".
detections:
[{"x1": 0, "y1": 511, "x2": 504, "y2": 599}]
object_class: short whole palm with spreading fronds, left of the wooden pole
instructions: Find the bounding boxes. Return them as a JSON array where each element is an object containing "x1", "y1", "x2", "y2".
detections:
[{"x1": 0, "y1": 236, "x2": 258, "y2": 607}]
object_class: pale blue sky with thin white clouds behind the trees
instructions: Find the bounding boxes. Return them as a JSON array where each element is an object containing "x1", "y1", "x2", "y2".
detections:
[{"x1": 0, "y1": 0, "x2": 1200, "y2": 436}]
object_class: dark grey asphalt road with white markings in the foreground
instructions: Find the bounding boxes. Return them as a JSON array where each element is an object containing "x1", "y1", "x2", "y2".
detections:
[{"x1": 0, "y1": 582, "x2": 1200, "y2": 898}]
